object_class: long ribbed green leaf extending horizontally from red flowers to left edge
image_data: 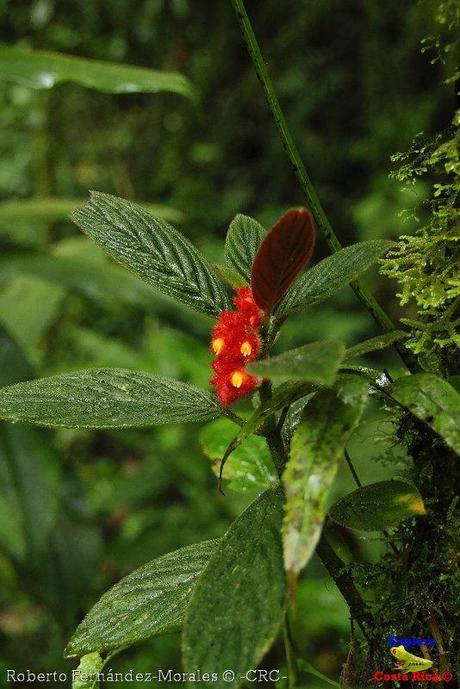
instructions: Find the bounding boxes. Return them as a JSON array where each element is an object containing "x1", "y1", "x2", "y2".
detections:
[{"x1": 0, "y1": 368, "x2": 222, "y2": 428}]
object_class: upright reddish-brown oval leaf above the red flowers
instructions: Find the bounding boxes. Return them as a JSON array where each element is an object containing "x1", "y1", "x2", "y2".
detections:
[{"x1": 251, "y1": 208, "x2": 315, "y2": 313}]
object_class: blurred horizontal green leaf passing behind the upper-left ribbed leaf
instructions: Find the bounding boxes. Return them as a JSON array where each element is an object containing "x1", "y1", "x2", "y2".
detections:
[{"x1": 0, "y1": 197, "x2": 183, "y2": 227}]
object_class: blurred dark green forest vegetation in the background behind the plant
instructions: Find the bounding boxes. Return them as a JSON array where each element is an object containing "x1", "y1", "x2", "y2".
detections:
[{"x1": 0, "y1": 0, "x2": 454, "y2": 687}]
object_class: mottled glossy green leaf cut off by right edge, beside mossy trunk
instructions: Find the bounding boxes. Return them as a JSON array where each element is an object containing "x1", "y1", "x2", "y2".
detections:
[{"x1": 385, "y1": 373, "x2": 460, "y2": 454}]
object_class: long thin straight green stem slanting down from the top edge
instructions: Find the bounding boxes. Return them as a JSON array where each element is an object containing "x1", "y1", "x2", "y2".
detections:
[{"x1": 232, "y1": 0, "x2": 410, "y2": 368}]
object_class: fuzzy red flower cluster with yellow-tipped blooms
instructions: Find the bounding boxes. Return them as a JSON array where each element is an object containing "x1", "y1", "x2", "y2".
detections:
[{"x1": 211, "y1": 287, "x2": 264, "y2": 407}]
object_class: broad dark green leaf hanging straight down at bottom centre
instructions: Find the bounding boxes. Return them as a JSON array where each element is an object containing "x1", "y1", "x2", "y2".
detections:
[{"x1": 182, "y1": 488, "x2": 286, "y2": 689}]
